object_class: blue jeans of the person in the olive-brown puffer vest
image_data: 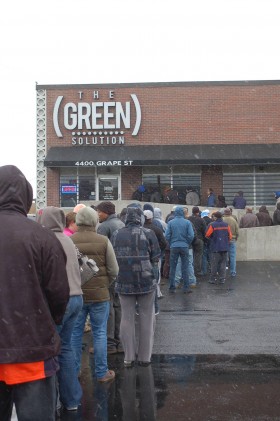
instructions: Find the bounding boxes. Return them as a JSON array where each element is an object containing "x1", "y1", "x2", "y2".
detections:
[{"x1": 72, "y1": 301, "x2": 110, "y2": 379}]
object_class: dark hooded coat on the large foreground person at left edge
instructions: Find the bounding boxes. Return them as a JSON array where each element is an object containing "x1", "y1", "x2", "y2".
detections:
[{"x1": 0, "y1": 165, "x2": 69, "y2": 364}]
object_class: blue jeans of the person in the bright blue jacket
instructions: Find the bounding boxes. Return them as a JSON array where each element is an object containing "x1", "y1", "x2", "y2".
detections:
[{"x1": 169, "y1": 247, "x2": 189, "y2": 290}]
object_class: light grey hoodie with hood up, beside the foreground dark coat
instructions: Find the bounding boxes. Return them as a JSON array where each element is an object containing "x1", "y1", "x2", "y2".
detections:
[{"x1": 38, "y1": 206, "x2": 83, "y2": 296}]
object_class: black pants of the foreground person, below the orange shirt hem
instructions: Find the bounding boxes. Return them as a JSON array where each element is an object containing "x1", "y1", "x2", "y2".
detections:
[{"x1": 0, "y1": 376, "x2": 56, "y2": 421}]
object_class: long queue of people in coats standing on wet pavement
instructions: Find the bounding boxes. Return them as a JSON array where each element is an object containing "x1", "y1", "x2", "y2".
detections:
[{"x1": 0, "y1": 165, "x2": 280, "y2": 421}]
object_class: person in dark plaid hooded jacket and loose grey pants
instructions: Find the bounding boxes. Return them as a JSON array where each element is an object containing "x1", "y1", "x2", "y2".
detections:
[{"x1": 112, "y1": 208, "x2": 160, "y2": 367}]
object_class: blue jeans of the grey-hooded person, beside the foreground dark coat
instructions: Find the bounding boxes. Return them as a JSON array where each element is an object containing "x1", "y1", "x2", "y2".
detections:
[{"x1": 56, "y1": 295, "x2": 83, "y2": 408}]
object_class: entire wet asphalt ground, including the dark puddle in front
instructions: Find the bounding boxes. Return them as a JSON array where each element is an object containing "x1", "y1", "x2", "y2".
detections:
[{"x1": 58, "y1": 262, "x2": 280, "y2": 421}]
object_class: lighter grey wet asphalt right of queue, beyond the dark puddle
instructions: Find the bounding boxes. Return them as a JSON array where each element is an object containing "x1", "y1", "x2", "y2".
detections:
[{"x1": 154, "y1": 262, "x2": 280, "y2": 354}]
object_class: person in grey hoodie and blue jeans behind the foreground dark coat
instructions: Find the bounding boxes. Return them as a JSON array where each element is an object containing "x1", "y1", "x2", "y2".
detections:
[{"x1": 38, "y1": 206, "x2": 83, "y2": 411}]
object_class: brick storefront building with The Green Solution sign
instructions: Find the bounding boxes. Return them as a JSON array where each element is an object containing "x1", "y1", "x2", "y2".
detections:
[{"x1": 36, "y1": 81, "x2": 280, "y2": 208}]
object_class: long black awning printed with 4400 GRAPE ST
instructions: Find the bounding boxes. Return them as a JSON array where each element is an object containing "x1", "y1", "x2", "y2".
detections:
[{"x1": 44, "y1": 144, "x2": 280, "y2": 168}]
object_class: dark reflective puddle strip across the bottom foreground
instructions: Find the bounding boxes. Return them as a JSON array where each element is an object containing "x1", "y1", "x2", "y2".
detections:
[{"x1": 61, "y1": 347, "x2": 280, "y2": 421}]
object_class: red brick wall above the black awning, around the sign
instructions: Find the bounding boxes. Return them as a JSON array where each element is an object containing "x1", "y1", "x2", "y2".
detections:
[{"x1": 44, "y1": 83, "x2": 280, "y2": 148}]
